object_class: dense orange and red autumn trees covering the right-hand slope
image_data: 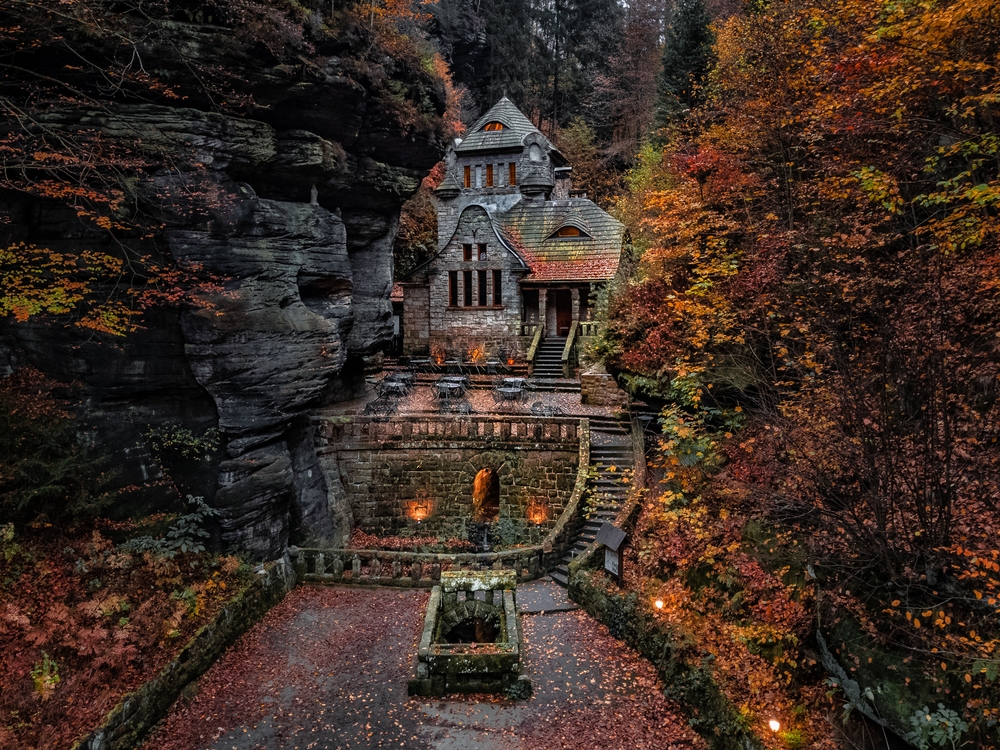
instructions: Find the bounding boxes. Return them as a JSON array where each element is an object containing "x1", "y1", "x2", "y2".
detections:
[{"x1": 599, "y1": 0, "x2": 1000, "y2": 746}]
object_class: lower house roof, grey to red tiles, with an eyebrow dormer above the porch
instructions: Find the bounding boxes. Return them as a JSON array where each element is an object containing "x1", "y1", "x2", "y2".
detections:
[{"x1": 496, "y1": 198, "x2": 625, "y2": 282}]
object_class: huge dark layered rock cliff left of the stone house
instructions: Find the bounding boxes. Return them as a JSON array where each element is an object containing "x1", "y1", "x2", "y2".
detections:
[{"x1": 0, "y1": 14, "x2": 444, "y2": 558}]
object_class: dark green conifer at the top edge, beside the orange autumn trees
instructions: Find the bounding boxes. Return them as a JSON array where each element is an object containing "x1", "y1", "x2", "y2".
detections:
[{"x1": 655, "y1": 0, "x2": 715, "y2": 128}]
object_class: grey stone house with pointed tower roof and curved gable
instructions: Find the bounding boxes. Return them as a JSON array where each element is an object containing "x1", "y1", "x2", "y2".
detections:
[{"x1": 400, "y1": 97, "x2": 624, "y2": 364}]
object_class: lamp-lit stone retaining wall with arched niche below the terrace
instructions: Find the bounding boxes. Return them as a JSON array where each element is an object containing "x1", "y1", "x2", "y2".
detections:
[{"x1": 317, "y1": 416, "x2": 585, "y2": 544}]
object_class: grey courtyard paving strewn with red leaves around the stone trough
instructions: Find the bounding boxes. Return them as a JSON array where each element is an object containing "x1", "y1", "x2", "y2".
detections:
[{"x1": 150, "y1": 579, "x2": 703, "y2": 750}]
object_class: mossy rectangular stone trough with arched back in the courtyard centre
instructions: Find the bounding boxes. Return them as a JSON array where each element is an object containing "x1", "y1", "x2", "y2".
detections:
[{"x1": 408, "y1": 570, "x2": 531, "y2": 695}]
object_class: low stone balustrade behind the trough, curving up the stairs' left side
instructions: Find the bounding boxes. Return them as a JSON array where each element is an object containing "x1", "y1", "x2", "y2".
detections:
[{"x1": 288, "y1": 419, "x2": 590, "y2": 588}]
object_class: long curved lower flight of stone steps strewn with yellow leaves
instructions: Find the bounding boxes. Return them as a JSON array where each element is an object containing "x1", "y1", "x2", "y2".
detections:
[{"x1": 550, "y1": 417, "x2": 635, "y2": 586}]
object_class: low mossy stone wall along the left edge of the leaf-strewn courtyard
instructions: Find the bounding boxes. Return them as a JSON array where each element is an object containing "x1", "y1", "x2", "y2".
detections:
[{"x1": 73, "y1": 559, "x2": 295, "y2": 750}]
